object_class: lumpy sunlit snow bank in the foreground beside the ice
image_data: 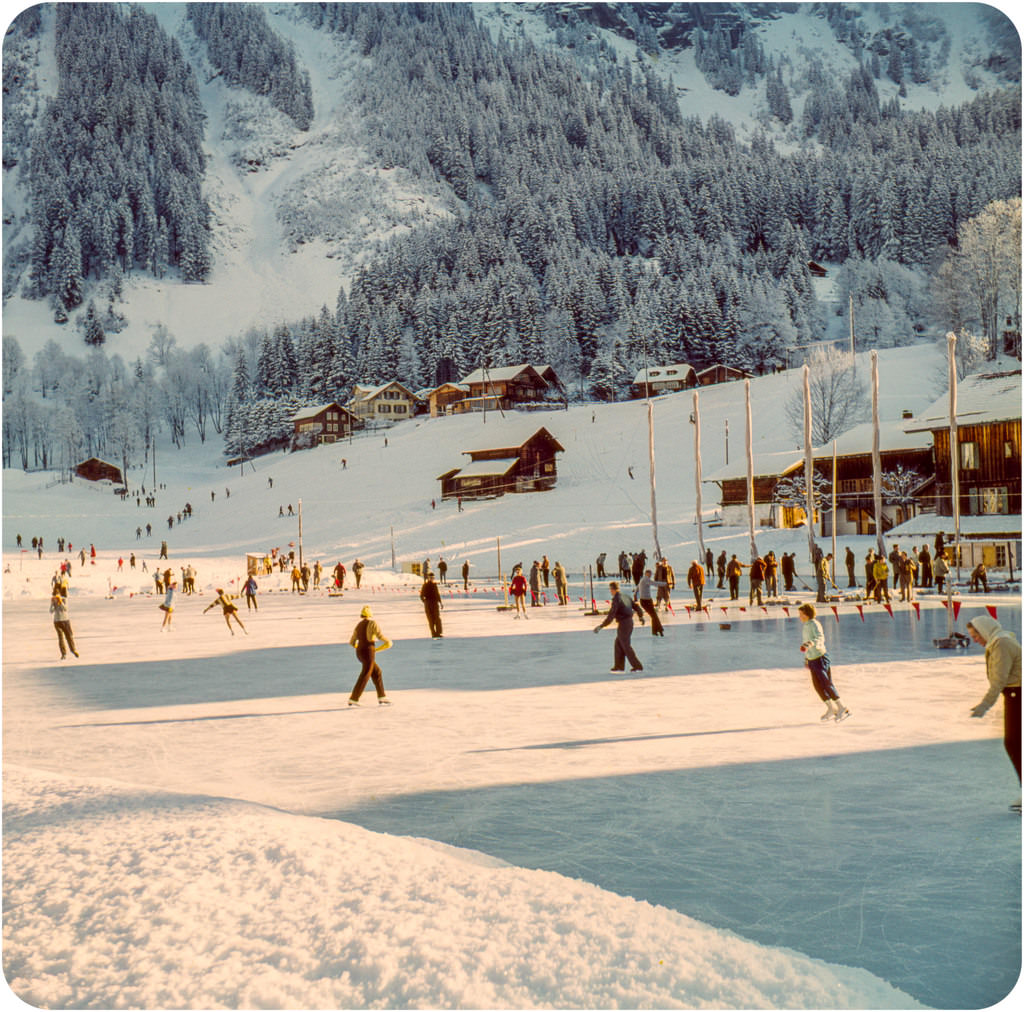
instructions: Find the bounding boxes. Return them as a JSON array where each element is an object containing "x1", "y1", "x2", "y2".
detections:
[{"x1": 4, "y1": 768, "x2": 922, "y2": 1008}]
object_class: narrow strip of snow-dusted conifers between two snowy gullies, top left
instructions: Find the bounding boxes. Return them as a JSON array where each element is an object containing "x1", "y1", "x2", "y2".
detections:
[{"x1": 187, "y1": 3, "x2": 313, "y2": 130}]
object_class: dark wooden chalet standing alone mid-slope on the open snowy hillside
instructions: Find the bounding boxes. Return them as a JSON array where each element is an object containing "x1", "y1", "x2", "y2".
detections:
[{"x1": 437, "y1": 427, "x2": 565, "y2": 499}]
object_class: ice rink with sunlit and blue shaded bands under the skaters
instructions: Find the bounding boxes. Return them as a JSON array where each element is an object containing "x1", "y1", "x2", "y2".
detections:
[{"x1": 4, "y1": 586, "x2": 1021, "y2": 1008}]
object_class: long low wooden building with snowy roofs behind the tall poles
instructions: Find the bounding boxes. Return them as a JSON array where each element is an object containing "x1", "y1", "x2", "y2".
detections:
[{"x1": 705, "y1": 421, "x2": 933, "y2": 536}]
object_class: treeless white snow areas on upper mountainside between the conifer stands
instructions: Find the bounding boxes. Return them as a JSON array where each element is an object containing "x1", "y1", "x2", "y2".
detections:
[{"x1": 3, "y1": 3, "x2": 1015, "y2": 361}]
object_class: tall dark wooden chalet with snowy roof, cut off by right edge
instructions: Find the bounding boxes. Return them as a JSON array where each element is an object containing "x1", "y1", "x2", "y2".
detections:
[{"x1": 907, "y1": 370, "x2": 1021, "y2": 522}]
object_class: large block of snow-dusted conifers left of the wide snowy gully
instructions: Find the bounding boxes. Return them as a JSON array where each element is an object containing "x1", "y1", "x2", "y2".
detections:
[{"x1": 29, "y1": 4, "x2": 210, "y2": 319}]
